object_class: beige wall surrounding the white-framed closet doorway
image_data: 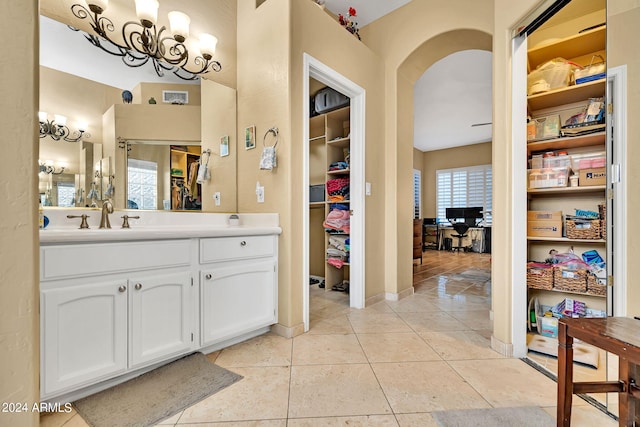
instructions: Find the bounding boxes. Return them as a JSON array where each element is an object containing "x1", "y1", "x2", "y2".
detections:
[{"x1": 290, "y1": 0, "x2": 388, "y2": 310}]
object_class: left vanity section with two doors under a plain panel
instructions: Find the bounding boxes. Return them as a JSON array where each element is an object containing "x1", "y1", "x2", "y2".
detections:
[{"x1": 40, "y1": 240, "x2": 198, "y2": 398}]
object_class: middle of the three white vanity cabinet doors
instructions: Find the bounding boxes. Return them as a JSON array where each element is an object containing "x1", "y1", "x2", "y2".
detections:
[{"x1": 129, "y1": 270, "x2": 194, "y2": 368}]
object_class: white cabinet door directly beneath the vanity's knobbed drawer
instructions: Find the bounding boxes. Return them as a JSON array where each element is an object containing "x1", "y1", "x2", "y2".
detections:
[{"x1": 200, "y1": 260, "x2": 277, "y2": 346}]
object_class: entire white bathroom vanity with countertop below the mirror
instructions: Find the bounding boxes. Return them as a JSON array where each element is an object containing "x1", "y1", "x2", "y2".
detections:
[{"x1": 40, "y1": 210, "x2": 281, "y2": 401}]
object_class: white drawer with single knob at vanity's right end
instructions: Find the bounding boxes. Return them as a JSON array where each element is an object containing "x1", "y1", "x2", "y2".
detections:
[{"x1": 200, "y1": 236, "x2": 276, "y2": 263}]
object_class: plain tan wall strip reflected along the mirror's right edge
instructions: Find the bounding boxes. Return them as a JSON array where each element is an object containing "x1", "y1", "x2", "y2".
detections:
[{"x1": 200, "y1": 80, "x2": 238, "y2": 212}]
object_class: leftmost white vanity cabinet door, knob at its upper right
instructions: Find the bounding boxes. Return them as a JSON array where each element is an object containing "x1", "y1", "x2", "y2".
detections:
[{"x1": 40, "y1": 280, "x2": 127, "y2": 396}]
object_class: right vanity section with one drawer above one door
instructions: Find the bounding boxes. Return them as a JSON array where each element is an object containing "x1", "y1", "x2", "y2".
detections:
[{"x1": 200, "y1": 236, "x2": 278, "y2": 347}]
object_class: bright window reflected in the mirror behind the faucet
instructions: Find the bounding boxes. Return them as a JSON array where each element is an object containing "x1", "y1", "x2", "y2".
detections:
[{"x1": 127, "y1": 159, "x2": 158, "y2": 209}]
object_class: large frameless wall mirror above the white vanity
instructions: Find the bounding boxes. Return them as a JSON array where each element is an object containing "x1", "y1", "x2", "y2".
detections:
[{"x1": 39, "y1": 11, "x2": 236, "y2": 212}]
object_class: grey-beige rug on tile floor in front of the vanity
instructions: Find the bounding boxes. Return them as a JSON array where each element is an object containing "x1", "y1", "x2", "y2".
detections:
[{"x1": 73, "y1": 353, "x2": 242, "y2": 427}]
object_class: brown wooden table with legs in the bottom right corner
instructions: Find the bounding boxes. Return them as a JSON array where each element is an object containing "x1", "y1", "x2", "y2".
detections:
[{"x1": 557, "y1": 317, "x2": 640, "y2": 427}]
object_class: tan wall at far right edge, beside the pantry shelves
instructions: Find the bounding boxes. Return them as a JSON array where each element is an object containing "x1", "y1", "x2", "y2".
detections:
[{"x1": 607, "y1": 0, "x2": 640, "y2": 316}]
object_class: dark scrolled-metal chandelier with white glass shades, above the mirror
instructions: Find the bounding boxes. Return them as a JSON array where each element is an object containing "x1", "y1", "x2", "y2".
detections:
[{"x1": 71, "y1": 0, "x2": 222, "y2": 80}]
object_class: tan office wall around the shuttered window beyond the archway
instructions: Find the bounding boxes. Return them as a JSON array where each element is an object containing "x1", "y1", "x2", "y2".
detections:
[{"x1": 422, "y1": 142, "x2": 491, "y2": 218}]
